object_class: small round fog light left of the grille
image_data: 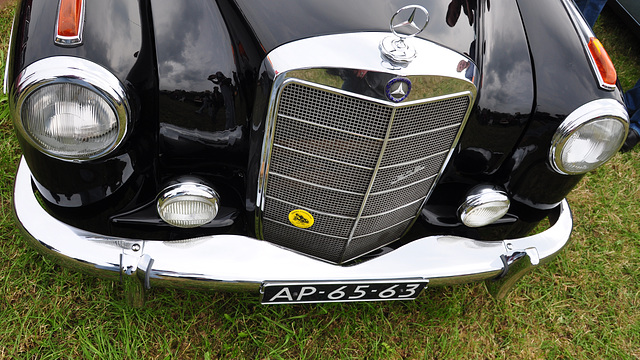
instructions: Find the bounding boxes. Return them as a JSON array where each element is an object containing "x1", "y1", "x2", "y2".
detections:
[{"x1": 158, "y1": 183, "x2": 220, "y2": 228}]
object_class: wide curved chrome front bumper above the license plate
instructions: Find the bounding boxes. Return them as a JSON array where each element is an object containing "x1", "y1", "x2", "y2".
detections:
[{"x1": 14, "y1": 159, "x2": 572, "y2": 306}]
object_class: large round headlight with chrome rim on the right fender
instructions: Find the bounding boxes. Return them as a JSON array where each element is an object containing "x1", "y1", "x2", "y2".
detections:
[{"x1": 549, "y1": 99, "x2": 629, "y2": 175}]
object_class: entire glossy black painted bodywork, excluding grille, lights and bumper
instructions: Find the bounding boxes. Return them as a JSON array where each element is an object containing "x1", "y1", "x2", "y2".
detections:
[{"x1": 9, "y1": 0, "x2": 620, "y2": 241}]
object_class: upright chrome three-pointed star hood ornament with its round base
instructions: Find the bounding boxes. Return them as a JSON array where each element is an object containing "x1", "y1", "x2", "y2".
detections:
[{"x1": 380, "y1": 5, "x2": 429, "y2": 65}]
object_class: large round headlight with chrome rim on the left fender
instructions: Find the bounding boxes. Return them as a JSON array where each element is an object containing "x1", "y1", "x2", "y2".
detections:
[{"x1": 14, "y1": 57, "x2": 129, "y2": 160}]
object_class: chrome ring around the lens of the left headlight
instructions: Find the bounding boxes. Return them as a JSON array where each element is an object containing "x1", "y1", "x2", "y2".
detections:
[{"x1": 11, "y1": 56, "x2": 131, "y2": 161}]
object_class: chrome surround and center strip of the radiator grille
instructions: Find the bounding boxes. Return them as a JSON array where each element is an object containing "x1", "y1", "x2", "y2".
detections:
[{"x1": 255, "y1": 32, "x2": 479, "y2": 260}]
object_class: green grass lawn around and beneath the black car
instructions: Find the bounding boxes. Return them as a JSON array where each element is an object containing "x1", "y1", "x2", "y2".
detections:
[{"x1": 0, "y1": 1, "x2": 640, "y2": 359}]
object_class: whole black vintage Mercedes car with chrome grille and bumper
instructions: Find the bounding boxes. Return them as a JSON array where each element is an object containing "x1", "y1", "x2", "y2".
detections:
[{"x1": 5, "y1": 0, "x2": 628, "y2": 305}]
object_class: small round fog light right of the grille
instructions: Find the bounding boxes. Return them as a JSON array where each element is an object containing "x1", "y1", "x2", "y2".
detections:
[{"x1": 458, "y1": 186, "x2": 510, "y2": 227}]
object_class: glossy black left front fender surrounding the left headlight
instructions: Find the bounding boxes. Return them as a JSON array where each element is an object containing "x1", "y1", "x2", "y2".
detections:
[{"x1": 9, "y1": 0, "x2": 157, "y2": 233}]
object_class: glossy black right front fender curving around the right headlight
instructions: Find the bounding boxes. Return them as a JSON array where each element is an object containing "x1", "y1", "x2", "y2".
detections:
[{"x1": 508, "y1": 0, "x2": 621, "y2": 208}]
